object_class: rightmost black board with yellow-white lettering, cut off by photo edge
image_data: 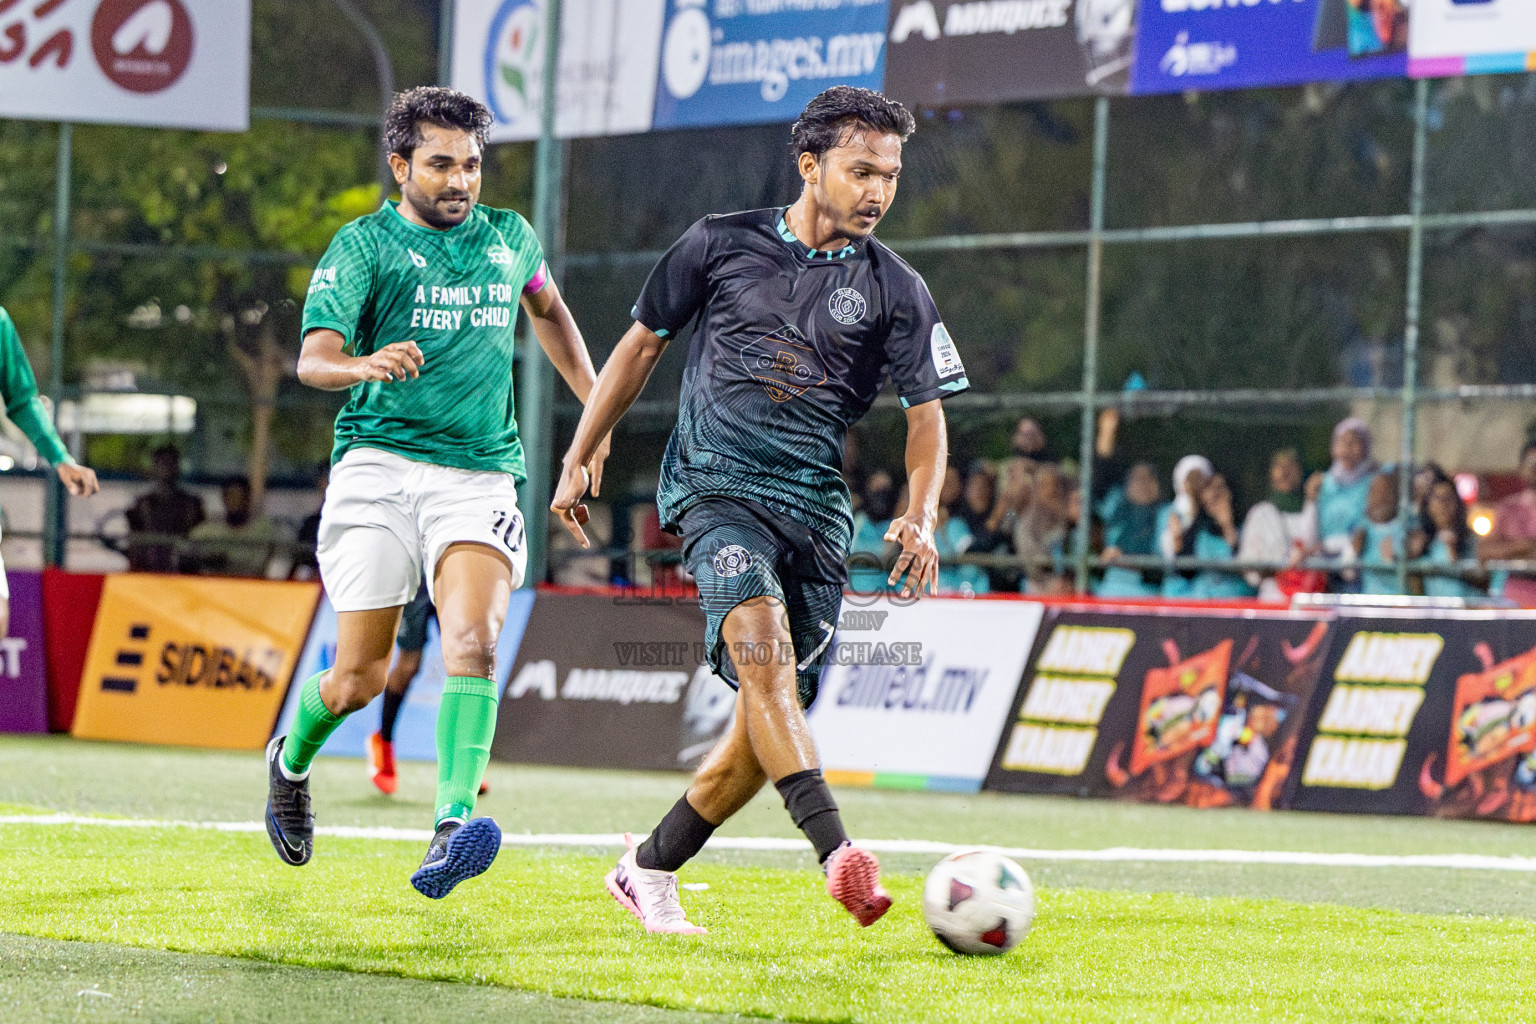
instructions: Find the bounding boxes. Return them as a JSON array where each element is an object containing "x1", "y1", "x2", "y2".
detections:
[{"x1": 1292, "y1": 611, "x2": 1536, "y2": 821}]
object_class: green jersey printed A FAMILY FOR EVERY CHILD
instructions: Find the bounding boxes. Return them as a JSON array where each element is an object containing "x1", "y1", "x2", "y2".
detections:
[{"x1": 303, "y1": 203, "x2": 547, "y2": 484}]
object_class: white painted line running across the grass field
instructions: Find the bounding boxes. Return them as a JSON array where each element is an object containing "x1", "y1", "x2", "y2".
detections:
[{"x1": 0, "y1": 814, "x2": 1536, "y2": 874}]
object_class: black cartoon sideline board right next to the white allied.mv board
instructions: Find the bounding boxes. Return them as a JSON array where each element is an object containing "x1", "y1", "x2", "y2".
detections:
[{"x1": 986, "y1": 608, "x2": 1329, "y2": 809}]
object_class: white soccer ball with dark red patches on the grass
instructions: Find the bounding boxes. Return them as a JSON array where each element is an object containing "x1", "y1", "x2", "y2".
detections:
[{"x1": 923, "y1": 851, "x2": 1035, "y2": 956}]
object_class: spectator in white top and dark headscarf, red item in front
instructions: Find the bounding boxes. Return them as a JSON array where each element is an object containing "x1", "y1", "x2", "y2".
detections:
[{"x1": 1238, "y1": 448, "x2": 1327, "y2": 600}]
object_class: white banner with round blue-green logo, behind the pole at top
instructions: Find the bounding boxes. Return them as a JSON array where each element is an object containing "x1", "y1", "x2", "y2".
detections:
[{"x1": 445, "y1": 0, "x2": 667, "y2": 143}]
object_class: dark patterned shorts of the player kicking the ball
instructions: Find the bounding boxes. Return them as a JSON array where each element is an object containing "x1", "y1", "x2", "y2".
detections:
[{"x1": 680, "y1": 497, "x2": 848, "y2": 708}]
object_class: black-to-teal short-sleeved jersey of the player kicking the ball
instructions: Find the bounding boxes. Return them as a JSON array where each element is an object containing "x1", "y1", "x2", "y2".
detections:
[{"x1": 634, "y1": 209, "x2": 969, "y2": 553}]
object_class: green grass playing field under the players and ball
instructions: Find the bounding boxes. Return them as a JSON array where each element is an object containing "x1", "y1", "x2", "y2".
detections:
[{"x1": 0, "y1": 738, "x2": 1536, "y2": 1024}]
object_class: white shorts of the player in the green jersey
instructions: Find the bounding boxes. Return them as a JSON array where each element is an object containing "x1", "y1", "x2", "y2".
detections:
[{"x1": 318, "y1": 448, "x2": 528, "y2": 611}]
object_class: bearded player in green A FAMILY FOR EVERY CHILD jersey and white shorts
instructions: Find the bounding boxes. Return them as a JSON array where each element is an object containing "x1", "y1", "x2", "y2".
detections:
[{"x1": 266, "y1": 88, "x2": 607, "y2": 900}]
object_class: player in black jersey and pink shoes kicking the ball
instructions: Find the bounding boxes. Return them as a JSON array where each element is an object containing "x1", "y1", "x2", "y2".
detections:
[{"x1": 551, "y1": 86, "x2": 968, "y2": 933}]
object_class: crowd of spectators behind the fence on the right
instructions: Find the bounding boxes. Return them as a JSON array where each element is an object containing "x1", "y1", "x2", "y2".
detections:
[{"x1": 848, "y1": 410, "x2": 1536, "y2": 603}]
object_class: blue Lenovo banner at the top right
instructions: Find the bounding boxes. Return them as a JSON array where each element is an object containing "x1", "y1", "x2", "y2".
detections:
[{"x1": 1130, "y1": 0, "x2": 1409, "y2": 94}]
